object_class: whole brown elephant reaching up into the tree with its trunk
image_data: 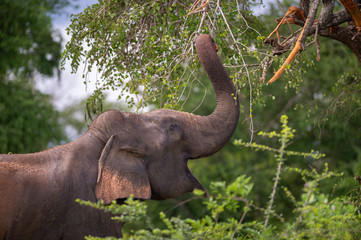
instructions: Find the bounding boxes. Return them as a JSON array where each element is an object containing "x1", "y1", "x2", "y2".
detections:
[{"x1": 0, "y1": 34, "x2": 239, "y2": 240}]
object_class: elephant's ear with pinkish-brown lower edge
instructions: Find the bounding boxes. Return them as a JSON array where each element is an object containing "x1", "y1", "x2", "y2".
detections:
[{"x1": 95, "y1": 135, "x2": 151, "y2": 204}]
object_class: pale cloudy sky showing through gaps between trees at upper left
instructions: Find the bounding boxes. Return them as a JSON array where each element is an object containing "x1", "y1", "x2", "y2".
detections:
[{"x1": 36, "y1": 0, "x2": 117, "y2": 110}]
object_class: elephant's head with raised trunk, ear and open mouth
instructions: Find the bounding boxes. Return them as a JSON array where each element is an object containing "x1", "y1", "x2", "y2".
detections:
[{"x1": 93, "y1": 35, "x2": 239, "y2": 204}]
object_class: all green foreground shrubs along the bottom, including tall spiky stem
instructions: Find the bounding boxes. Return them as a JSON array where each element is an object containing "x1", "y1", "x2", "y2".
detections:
[{"x1": 78, "y1": 116, "x2": 361, "y2": 240}]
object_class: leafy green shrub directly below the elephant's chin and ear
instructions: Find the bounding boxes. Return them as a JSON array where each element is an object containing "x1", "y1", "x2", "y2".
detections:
[{"x1": 77, "y1": 176, "x2": 262, "y2": 240}]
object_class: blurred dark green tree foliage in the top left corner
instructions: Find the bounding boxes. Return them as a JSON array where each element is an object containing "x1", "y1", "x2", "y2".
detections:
[{"x1": 0, "y1": 0, "x2": 68, "y2": 77}]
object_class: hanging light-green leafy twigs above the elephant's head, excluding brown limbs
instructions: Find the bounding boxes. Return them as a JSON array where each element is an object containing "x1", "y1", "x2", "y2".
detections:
[{"x1": 63, "y1": 0, "x2": 261, "y2": 109}]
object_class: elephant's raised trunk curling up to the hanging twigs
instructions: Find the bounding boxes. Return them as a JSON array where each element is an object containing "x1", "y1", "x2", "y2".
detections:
[{"x1": 191, "y1": 35, "x2": 239, "y2": 158}]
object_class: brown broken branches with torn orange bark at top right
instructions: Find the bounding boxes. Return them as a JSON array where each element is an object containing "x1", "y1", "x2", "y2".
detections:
[{"x1": 265, "y1": 0, "x2": 361, "y2": 83}]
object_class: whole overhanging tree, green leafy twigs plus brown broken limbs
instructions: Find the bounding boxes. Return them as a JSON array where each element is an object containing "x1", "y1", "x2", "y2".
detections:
[{"x1": 63, "y1": 0, "x2": 361, "y2": 108}]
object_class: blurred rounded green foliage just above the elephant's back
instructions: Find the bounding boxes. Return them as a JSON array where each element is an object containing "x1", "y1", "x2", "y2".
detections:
[{"x1": 0, "y1": 80, "x2": 66, "y2": 153}]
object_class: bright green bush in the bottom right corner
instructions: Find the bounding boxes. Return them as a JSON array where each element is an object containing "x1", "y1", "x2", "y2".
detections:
[{"x1": 260, "y1": 166, "x2": 361, "y2": 240}]
